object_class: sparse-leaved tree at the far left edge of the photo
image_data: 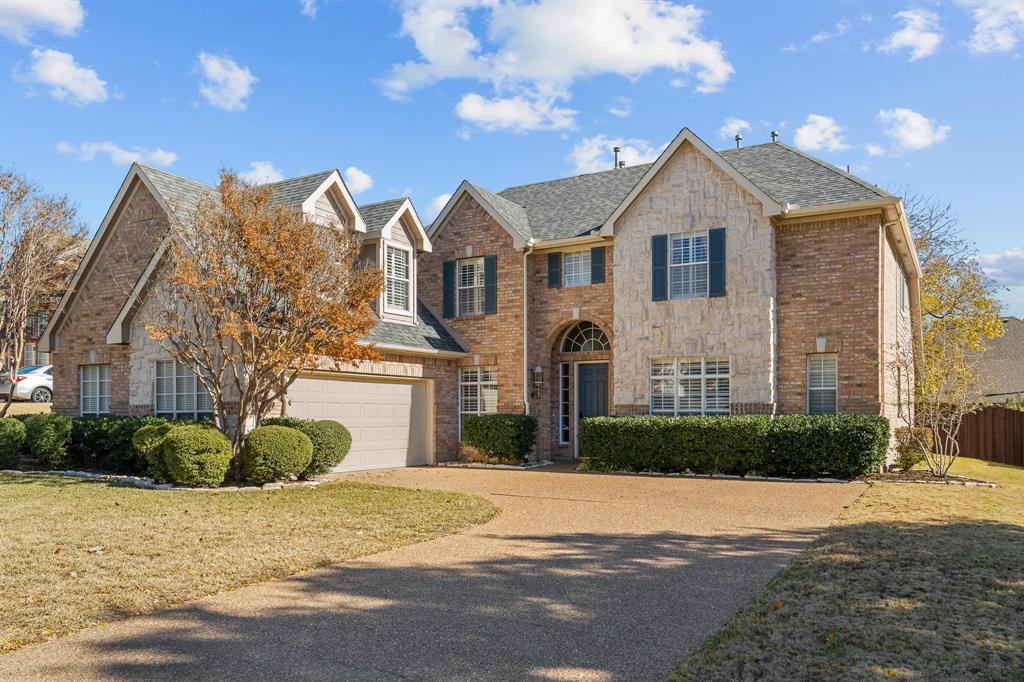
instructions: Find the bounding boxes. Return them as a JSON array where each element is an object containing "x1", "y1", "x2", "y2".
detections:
[{"x1": 0, "y1": 171, "x2": 85, "y2": 416}]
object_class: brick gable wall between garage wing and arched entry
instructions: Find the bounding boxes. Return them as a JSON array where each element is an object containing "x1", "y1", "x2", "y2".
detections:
[{"x1": 418, "y1": 195, "x2": 524, "y2": 414}]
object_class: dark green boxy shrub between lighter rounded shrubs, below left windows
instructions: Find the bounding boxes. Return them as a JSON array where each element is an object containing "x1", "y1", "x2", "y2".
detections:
[{"x1": 68, "y1": 416, "x2": 168, "y2": 475}]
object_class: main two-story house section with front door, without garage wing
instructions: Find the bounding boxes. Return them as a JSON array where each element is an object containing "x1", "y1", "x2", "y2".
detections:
[{"x1": 420, "y1": 129, "x2": 920, "y2": 458}]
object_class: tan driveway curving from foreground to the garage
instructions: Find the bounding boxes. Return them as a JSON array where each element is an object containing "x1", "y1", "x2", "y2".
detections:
[{"x1": 0, "y1": 468, "x2": 864, "y2": 681}]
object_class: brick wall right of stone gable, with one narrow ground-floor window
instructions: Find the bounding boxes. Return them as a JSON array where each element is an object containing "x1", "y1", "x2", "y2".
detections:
[{"x1": 775, "y1": 214, "x2": 883, "y2": 415}]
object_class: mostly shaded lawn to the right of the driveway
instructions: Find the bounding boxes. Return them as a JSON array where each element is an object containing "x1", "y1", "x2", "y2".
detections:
[{"x1": 673, "y1": 459, "x2": 1024, "y2": 680}]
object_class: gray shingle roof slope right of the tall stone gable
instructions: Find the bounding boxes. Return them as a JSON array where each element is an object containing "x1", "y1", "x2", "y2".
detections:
[{"x1": 719, "y1": 142, "x2": 893, "y2": 208}]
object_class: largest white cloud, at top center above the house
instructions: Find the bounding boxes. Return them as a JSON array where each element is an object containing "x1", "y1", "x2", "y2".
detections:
[{"x1": 382, "y1": 0, "x2": 733, "y2": 130}]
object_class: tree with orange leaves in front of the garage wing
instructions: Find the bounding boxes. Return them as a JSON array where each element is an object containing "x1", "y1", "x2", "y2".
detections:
[{"x1": 141, "y1": 170, "x2": 382, "y2": 475}]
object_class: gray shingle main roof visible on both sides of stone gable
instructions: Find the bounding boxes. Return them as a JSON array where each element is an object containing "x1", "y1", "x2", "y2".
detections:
[{"x1": 473, "y1": 142, "x2": 894, "y2": 241}]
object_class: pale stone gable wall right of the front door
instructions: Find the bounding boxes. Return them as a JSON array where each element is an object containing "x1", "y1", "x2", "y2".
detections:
[{"x1": 613, "y1": 142, "x2": 775, "y2": 414}]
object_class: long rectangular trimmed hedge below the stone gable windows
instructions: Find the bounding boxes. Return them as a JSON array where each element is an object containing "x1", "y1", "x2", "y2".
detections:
[{"x1": 580, "y1": 415, "x2": 889, "y2": 478}]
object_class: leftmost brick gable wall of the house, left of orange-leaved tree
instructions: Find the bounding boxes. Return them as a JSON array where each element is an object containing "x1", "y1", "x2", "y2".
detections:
[{"x1": 53, "y1": 180, "x2": 168, "y2": 416}]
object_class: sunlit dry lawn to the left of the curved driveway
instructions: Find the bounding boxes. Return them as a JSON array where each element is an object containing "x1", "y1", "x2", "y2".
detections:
[{"x1": 0, "y1": 475, "x2": 497, "y2": 653}]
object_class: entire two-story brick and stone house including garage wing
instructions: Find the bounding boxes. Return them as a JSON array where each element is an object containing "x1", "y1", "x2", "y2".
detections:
[{"x1": 41, "y1": 124, "x2": 920, "y2": 469}]
